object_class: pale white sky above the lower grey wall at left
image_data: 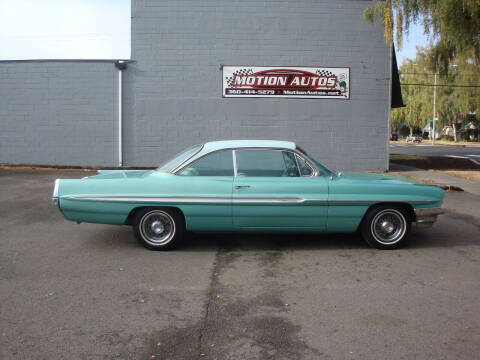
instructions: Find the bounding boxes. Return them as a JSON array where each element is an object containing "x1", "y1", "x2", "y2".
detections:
[{"x1": 0, "y1": 0, "x2": 130, "y2": 60}]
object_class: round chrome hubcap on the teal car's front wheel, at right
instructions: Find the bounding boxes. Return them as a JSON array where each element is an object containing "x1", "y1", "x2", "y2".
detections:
[{"x1": 371, "y1": 209, "x2": 407, "y2": 245}]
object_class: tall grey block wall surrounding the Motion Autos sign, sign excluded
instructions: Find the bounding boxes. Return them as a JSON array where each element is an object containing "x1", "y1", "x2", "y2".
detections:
[{"x1": 131, "y1": 0, "x2": 390, "y2": 170}]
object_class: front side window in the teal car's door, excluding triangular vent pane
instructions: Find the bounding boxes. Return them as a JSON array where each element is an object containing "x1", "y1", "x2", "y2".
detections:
[{"x1": 235, "y1": 150, "x2": 300, "y2": 177}]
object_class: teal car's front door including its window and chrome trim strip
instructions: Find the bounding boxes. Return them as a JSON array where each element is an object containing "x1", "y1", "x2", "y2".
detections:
[{"x1": 233, "y1": 149, "x2": 328, "y2": 231}]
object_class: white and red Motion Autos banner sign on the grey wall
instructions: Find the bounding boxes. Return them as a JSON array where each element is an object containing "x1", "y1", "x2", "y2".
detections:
[{"x1": 223, "y1": 66, "x2": 350, "y2": 100}]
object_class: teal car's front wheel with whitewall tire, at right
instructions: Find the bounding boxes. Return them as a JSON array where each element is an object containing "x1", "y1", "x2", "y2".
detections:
[{"x1": 361, "y1": 205, "x2": 411, "y2": 250}]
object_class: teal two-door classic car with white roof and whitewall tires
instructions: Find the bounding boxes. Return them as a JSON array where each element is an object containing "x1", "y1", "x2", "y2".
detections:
[{"x1": 53, "y1": 140, "x2": 444, "y2": 250}]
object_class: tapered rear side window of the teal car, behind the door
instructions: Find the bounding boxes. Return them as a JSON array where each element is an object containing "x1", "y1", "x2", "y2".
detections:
[{"x1": 178, "y1": 150, "x2": 233, "y2": 176}]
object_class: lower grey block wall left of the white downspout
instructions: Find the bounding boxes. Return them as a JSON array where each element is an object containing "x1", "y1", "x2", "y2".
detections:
[{"x1": 0, "y1": 61, "x2": 118, "y2": 166}]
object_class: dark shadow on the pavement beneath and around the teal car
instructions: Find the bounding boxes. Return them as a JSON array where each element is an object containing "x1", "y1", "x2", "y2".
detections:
[{"x1": 88, "y1": 214, "x2": 480, "y2": 252}]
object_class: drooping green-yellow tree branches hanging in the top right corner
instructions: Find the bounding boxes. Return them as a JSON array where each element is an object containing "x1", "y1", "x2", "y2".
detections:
[{"x1": 363, "y1": 0, "x2": 480, "y2": 67}]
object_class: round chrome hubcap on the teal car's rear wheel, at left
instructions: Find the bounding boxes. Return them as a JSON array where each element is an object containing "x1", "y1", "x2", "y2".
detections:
[{"x1": 140, "y1": 210, "x2": 175, "y2": 245}]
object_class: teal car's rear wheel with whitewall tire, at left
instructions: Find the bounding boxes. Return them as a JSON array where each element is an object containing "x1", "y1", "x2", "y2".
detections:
[{"x1": 133, "y1": 208, "x2": 185, "y2": 250}]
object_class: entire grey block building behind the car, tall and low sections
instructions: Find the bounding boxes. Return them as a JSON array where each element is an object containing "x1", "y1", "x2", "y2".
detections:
[{"x1": 0, "y1": 0, "x2": 401, "y2": 170}]
